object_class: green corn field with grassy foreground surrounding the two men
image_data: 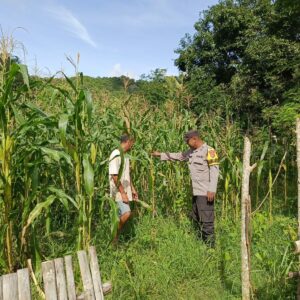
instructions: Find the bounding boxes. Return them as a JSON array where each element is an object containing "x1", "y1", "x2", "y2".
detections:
[{"x1": 0, "y1": 18, "x2": 298, "y2": 299}]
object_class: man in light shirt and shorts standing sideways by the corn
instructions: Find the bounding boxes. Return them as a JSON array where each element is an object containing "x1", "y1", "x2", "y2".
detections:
[{"x1": 109, "y1": 134, "x2": 138, "y2": 241}]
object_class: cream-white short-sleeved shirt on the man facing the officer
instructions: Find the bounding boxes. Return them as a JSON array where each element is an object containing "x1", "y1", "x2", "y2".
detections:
[{"x1": 109, "y1": 149, "x2": 132, "y2": 201}]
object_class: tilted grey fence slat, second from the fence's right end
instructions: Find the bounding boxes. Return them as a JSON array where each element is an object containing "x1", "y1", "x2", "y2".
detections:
[{"x1": 77, "y1": 250, "x2": 95, "y2": 300}]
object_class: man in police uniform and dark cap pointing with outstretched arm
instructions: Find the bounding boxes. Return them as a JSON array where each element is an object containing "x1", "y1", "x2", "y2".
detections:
[{"x1": 152, "y1": 130, "x2": 219, "y2": 245}]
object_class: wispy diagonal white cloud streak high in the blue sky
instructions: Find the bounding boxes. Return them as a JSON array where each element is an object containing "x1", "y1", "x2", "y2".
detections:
[{"x1": 47, "y1": 6, "x2": 97, "y2": 48}]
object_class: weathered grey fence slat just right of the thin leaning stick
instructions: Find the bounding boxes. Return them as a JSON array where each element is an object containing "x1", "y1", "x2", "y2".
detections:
[{"x1": 42, "y1": 260, "x2": 58, "y2": 300}]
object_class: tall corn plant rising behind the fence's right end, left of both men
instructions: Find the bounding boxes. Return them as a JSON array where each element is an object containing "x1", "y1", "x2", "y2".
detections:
[{"x1": 43, "y1": 69, "x2": 97, "y2": 248}]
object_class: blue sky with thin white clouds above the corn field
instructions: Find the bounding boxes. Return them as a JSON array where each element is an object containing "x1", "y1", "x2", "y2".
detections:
[{"x1": 0, "y1": 0, "x2": 218, "y2": 79}]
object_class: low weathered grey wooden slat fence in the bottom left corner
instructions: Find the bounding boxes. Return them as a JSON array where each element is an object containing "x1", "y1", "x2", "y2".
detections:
[{"x1": 0, "y1": 246, "x2": 112, "y2": 300}]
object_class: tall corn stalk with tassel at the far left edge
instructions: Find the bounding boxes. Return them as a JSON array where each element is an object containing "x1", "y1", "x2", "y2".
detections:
[{"x1": 0, "y1": 39, "x2": 35, "y2": 271}]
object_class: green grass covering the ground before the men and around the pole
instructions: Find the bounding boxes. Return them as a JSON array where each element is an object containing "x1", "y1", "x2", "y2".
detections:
[{"x1": 64, "y1": 214, "x2": 296, "y2": 300}]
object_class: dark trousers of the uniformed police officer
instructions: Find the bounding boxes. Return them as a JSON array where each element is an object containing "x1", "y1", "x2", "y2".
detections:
[{"x1": 191, "y1": 196, "x2": 215, "y2": 245}]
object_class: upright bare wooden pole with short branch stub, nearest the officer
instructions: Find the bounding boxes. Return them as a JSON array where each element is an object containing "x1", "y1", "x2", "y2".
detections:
[{"x1": 241, "y1": 137, "x2": 256, "y2": 300}]
